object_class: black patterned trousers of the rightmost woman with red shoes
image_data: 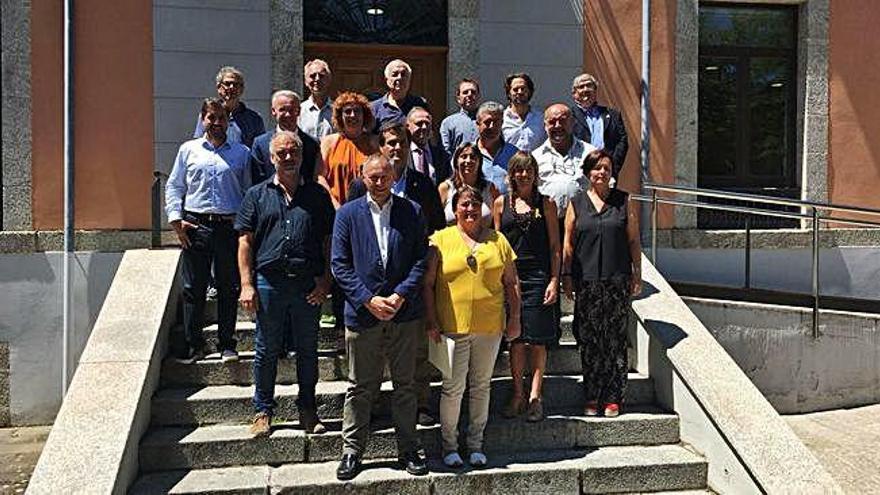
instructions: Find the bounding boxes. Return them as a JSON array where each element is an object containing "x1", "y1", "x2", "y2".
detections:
[{"x1": 574, "y1": 276, "x2": 630, "y2": 404}]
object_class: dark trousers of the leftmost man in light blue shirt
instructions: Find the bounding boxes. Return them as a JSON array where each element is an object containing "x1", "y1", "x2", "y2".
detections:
[{"x1": 182, "y1": 221, "x2": 239, "y2": 351}]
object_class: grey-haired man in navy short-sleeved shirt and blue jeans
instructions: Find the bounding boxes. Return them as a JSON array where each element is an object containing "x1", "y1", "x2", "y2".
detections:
[{"x1": 235, "y1": 131, "x2": 334, "y2": 436}]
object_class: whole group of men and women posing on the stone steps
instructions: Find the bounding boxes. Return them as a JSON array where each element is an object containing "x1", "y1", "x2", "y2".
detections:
[{"x1": 165, "y1": 59, "x2": 641, "y2": 480}]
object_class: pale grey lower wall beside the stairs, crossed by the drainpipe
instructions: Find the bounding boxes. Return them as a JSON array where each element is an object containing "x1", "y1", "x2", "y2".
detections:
[{"x1": 0, "y1": 252, "x2": 122, "y2": 425}]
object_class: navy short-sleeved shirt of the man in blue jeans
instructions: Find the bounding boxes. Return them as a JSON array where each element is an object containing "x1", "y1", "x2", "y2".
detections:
[{"x1": 235, "y1": 180, "x2": 335, "y2": 276}]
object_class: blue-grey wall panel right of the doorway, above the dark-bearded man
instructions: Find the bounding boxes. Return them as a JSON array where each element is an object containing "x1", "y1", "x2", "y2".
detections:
[{"x1": 474, "y1": 0, "x2": 584, "y2": 111}]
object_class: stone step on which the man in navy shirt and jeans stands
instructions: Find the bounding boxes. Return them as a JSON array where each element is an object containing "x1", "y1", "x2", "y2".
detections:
[{"x1": 140, "y1": 410, "x2": 679, "y2": 472}]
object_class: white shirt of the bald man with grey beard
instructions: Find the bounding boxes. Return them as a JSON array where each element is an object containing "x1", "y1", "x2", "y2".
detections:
[{"x1": 532, "y1": 136, "x2": 596, "y2": 218}]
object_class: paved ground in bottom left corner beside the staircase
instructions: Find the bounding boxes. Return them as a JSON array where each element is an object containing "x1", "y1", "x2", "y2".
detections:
[{"x1": 0, "y1": 426, "x2": 51, "y2": 495}]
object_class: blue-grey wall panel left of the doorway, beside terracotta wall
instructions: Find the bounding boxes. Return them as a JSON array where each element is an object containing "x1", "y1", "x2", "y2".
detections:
[{"x1": 153, "y1": 0, "x2": 272, "y2": 178}]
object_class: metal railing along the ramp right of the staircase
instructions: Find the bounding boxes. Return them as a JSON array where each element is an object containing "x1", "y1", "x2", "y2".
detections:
[{"x1": 631, "y1": 183, "x2": 880, "y2": 339}]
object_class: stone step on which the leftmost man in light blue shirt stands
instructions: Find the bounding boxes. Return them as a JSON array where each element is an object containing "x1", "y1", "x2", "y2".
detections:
[{"x1": 161, "y1": 342, "x2": 581, "y2": 387}]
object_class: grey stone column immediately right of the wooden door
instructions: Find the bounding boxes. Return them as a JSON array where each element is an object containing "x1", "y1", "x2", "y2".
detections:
[{"x1": 446, "y1": 0, "x2": 480, "y2": 113}]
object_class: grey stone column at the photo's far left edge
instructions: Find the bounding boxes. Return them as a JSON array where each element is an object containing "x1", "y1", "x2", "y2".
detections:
[{"x1": 2, "y1": 0, "x2": 32, "y2": 230}]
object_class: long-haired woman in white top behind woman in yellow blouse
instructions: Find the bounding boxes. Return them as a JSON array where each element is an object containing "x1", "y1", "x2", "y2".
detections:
[{"x1": 437, "y1": 143, "x2": 498, "y2": 227}]
